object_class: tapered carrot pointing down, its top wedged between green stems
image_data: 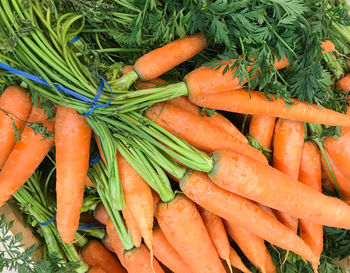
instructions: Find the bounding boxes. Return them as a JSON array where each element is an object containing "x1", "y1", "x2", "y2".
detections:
[{"x1": 117, "y1": 153, "x2": 154, "y2": 249}]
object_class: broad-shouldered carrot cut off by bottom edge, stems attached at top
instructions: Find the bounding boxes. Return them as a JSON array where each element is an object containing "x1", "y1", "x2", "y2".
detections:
[{"x1": 156, "y1": 195, "x2": 225, "y2": 273}]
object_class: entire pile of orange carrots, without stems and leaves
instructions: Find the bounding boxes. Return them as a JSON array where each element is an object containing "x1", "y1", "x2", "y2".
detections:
[{"x1": 0, "y1": 34, "x2": 350, "y2": 273}]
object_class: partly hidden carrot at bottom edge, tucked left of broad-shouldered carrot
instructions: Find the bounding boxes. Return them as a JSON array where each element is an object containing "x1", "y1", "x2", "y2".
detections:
[{"x1": 152, "y1": 227, "x2": 191, "y2": 273}]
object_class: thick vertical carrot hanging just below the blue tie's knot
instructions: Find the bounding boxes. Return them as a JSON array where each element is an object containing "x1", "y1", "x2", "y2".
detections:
[{"x1": 55, "y1": 105, "x2": 92, "y2": 243}]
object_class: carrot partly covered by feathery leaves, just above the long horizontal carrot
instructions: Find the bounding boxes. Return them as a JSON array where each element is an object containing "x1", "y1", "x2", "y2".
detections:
[{"x1": 184, "y1": 55, "x2": 289, "y2": 97}]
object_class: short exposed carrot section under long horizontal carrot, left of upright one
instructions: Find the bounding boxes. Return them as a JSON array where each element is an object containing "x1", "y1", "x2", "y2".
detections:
[{"x1": 249, "y1": 116, "x2": 276, "y2": 149}]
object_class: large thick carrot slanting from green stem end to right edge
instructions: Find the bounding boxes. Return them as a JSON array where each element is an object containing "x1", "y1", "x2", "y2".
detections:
[{"x1": 209, "y1": 151, "x2": 350, "y2": 230}]
